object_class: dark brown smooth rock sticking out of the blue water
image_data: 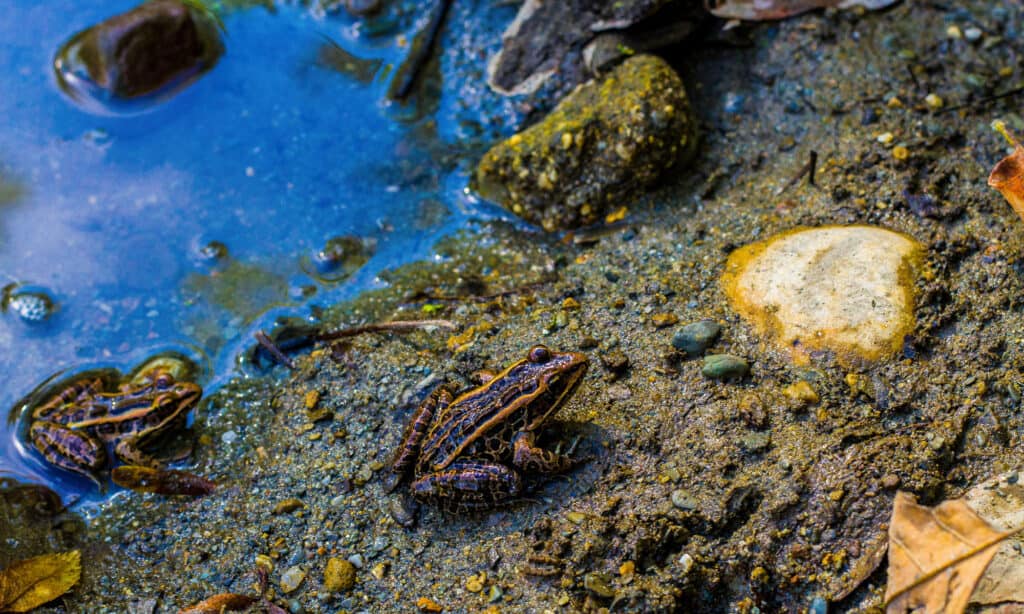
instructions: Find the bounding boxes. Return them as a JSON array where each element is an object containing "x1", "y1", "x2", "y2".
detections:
[{"x1": 53, "y1": 0, "x2": 224, "y2": 111}]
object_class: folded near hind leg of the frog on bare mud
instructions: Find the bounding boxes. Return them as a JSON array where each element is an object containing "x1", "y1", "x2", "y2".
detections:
[{"x1": 412, "y1": 459, "x2": 522, "y2": 512}]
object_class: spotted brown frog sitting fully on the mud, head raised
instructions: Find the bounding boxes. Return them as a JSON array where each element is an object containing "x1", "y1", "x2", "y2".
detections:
[{"x1": 390, "y1": 345, "x2": 589, "y2": 511}]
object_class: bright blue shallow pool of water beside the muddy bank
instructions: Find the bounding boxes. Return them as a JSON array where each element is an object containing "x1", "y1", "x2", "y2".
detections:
[{"x1": 0, "y1": 0, "x2": 514, "y2": 499}]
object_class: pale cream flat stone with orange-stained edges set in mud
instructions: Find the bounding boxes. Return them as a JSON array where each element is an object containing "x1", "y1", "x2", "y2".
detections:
[{"x1": 722, "y1": 226, "x2": 924, "y2": 362}]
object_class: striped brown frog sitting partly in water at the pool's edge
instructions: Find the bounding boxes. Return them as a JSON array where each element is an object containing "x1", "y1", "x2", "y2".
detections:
[{"x1": 29, "y1": 367, "x2": 203, "y2": 483}]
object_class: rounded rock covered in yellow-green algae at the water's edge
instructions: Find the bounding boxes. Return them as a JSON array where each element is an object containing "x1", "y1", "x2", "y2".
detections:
[{"x1": 476, "y1": 55, "x2": 696, "y2": 231}]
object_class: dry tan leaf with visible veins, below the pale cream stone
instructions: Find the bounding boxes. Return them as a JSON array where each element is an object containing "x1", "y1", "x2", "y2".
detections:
[{"x1": 886, "y1": 492, "x2": 1014, "y2": 614}]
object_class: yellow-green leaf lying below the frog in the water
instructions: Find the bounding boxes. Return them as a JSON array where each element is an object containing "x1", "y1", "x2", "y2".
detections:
[{"x1": 0, "y1": 551, "x2": 82, "y2": 612}]
